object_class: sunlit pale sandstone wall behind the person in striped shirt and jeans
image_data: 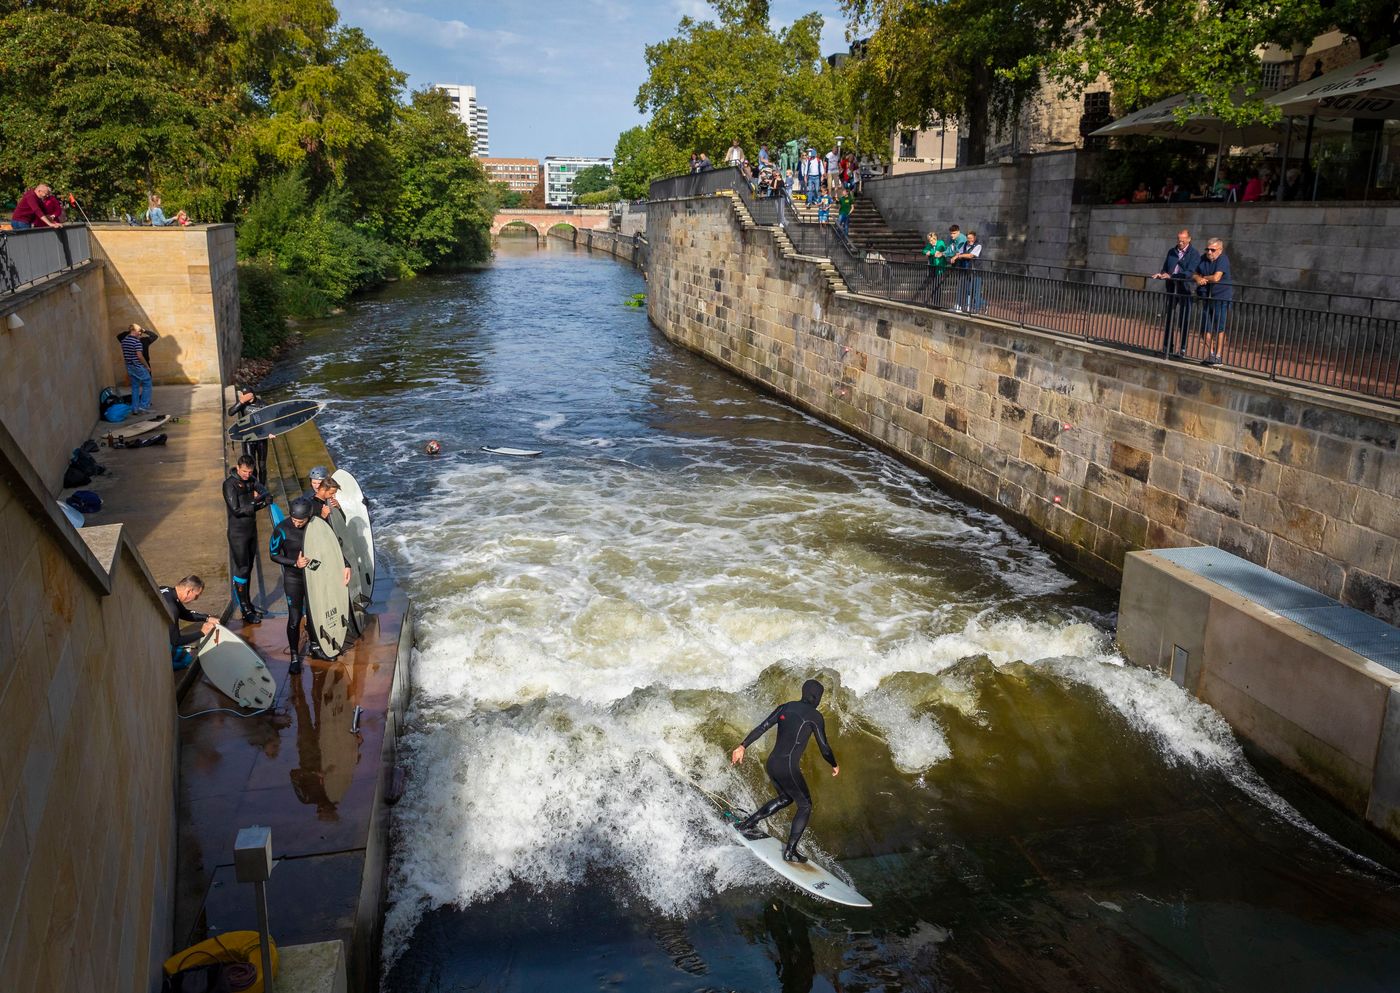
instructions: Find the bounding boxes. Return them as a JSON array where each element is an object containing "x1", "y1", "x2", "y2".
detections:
[{"x1": 92, "y1": 224, "x2": 242, "y2": 384}]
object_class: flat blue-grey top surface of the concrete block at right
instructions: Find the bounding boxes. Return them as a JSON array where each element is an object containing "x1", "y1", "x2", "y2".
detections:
[{"x1": 1152, "y1": 546, "x2": 1400, "y2": 672}]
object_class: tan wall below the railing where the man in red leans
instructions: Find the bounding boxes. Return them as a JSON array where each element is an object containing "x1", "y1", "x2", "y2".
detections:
[{"x1": 0, "y1": 263, "x2": 110, "y2": 493}]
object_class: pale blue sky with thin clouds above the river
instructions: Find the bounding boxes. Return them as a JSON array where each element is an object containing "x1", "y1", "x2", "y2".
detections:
[{"x1": 336, "y1": 0, "x2": 846, "y2": 158}]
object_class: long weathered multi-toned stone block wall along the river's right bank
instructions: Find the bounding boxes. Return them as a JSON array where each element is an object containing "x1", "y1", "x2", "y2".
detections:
[{"x1": 647, "y1": 197, "x2": 1400, "y2": 623}]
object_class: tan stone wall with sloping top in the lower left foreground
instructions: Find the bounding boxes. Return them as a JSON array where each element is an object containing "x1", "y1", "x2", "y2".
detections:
[{"x1": 0, "y1": 430, "x2": 175, "y2": 993}]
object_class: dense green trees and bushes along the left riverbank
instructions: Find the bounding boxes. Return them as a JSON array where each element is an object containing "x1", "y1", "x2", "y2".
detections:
[{"x1": 0, "y1": 0, "x2": 497, "y2": 354}]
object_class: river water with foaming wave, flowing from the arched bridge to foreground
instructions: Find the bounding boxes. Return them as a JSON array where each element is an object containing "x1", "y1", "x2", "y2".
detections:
[{"x1": 263, "y1": 239, "x2": 1400, "y2": 993}]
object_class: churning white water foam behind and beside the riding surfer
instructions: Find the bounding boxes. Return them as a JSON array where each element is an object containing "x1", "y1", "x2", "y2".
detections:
[{"x1": 384, "y1": 440, "x2": 1321, "y2": 962}]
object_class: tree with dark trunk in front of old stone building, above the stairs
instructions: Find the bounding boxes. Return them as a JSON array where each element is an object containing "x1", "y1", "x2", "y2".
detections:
[{"x1": 841, "y1": 0, "x2": 1080, "y2": 165}]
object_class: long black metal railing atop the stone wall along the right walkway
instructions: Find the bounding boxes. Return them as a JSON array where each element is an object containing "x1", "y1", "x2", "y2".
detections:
[{"x1": 651, "y1": 175, "x2": 1400, "y2": 401}]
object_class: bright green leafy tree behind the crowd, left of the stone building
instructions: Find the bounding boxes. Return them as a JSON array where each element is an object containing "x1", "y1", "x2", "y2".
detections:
[{"x1": 641, "y1": 0, "x2": 848, "y2": 164}]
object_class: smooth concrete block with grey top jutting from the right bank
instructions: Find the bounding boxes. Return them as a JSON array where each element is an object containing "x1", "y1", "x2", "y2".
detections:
[{"x1": 1117, "y1": 548, "x2": 1400, "y2": 843}]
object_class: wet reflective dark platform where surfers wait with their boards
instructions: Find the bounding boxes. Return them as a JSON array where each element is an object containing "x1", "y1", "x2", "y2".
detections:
[{"x1": 175, "y1": 427, "x2": 412, "y2": 990}]
